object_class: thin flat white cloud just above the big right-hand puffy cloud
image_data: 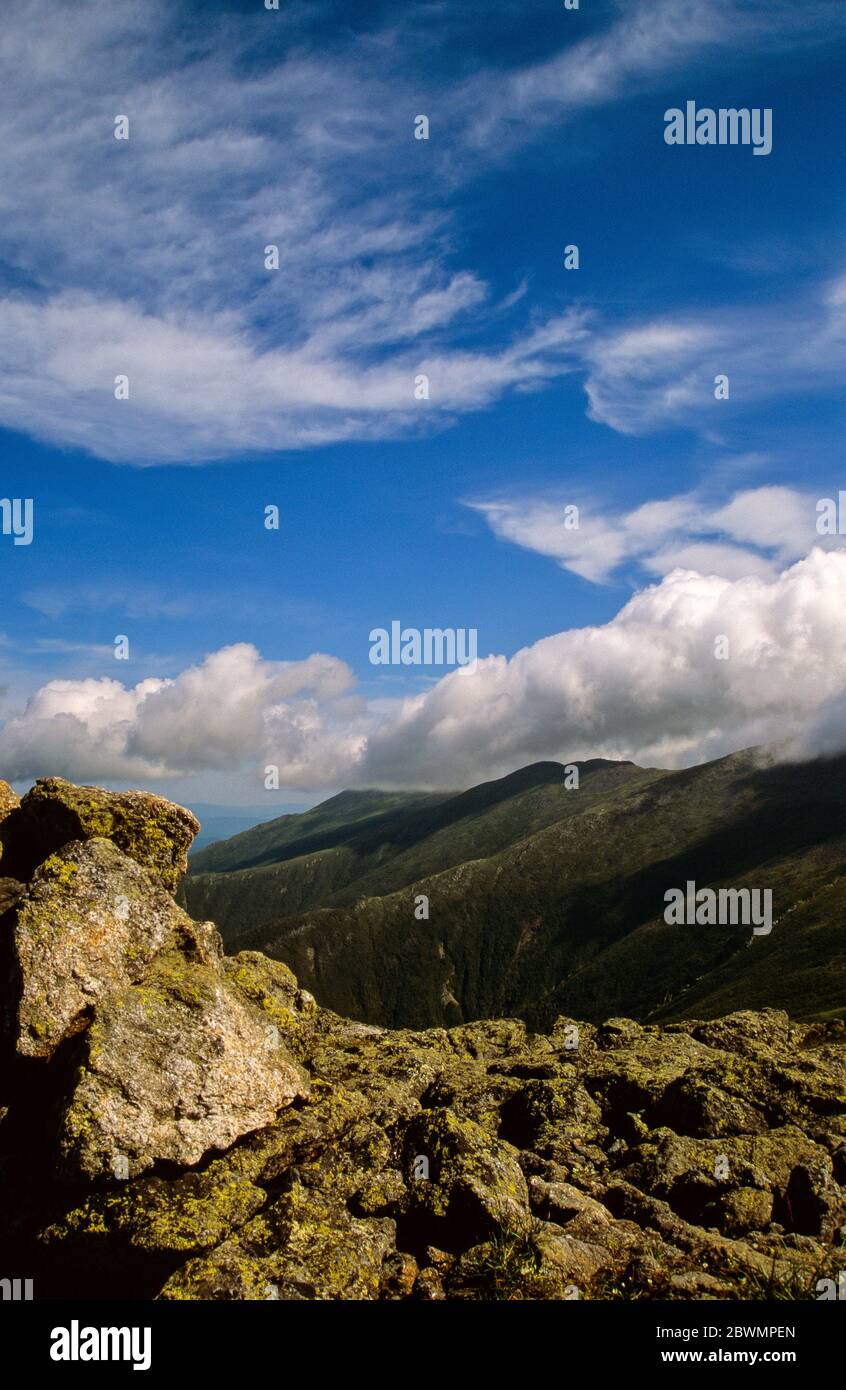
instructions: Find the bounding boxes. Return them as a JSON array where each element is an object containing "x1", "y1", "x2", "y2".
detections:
[{"x1": 467, "y1": 487, "x2": 822, "y2": 584}]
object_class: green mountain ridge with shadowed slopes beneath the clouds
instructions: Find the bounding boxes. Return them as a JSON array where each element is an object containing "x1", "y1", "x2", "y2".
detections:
[{"x1": 182, "y1": 751, "x2": 846, "y2": 1027}]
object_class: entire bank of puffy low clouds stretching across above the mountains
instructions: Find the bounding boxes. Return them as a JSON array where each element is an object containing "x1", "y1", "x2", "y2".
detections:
[{"x1": 0, "y1": 548, "x2": 846, "y2": 788}]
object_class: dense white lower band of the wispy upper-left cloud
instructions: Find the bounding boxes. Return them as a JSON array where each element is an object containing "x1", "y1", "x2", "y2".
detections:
[{"x1": 0, "y1": 279, "x2": 583, "y2": 461}]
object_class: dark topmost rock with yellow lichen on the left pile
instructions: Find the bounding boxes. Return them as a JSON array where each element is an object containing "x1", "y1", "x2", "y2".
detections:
[{"x1": 0, "y1": 777, "x2": 200, "y2": 892}]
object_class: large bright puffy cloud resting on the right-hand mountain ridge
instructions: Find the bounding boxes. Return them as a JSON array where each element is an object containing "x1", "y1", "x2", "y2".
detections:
[{"x1": 365, "y1": 549, "x2": 846, "y2": 785}]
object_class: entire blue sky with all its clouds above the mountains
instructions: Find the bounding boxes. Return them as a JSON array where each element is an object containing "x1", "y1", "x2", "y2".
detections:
[{"x1": 0, "y1": 0, "x2": 846, "y2": 805}]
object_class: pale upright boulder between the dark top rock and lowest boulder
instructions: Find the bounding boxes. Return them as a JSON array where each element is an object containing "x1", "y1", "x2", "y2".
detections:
[{"x1": 15, "y1": 840, "x2": 214, "y2": 1056}]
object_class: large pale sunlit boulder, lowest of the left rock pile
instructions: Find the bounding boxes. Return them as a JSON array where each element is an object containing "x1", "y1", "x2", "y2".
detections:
[{"x1": 60, "y1": 952, "x2": 307, "y2": 1179}]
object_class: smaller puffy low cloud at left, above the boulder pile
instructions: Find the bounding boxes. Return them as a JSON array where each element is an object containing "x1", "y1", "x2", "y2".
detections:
[{"x1": 0, "y1": 644, "x2": 363, "y2": 785}]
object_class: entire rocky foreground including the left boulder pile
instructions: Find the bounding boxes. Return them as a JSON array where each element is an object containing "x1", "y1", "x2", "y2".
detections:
[{"x1": 0, "y1": 778, "x2": 846, "y2": 1300}]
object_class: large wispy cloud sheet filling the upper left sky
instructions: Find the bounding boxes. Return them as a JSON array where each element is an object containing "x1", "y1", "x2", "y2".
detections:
[{"x1": 0, "y1": 0, "x2": 579, "y2": 463}]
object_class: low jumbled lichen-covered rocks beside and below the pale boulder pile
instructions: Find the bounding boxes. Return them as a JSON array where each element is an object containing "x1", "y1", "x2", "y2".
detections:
[{"x1": 8, "y1": 978, "x2": 846, "y2": 1300}]
